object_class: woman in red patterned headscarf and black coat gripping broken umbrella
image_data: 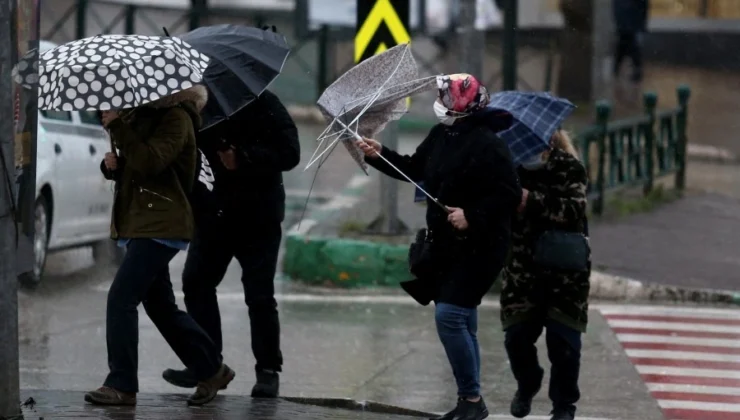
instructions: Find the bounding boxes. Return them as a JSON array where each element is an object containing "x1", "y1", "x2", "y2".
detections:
[{"x1": 357, "y1": 74, "x2": 521, "y2": 420}]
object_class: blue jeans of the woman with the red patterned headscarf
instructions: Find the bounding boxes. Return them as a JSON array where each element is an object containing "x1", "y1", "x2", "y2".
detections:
[{"x1": 434, "y1": 303, "x2": 480, "y2": 398}]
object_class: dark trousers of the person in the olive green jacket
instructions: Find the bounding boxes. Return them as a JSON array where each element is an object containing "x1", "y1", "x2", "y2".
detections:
[{"x1": 105, "y1": 239, "x2": 221, "y2": 392}]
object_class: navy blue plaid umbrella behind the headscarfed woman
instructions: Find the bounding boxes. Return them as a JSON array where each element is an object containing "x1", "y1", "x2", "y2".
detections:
[{"x1": 487, "y1": 91, "x2": 575, "y2": 165}]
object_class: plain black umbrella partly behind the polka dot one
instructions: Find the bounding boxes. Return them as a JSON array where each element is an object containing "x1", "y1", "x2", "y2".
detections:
[{"x1": 180, "y1": 25, "x2": 290, "y2": 129}]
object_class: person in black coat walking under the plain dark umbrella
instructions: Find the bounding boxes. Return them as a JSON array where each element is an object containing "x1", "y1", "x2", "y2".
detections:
[{"x1": 163, "y1": 91, "x2": 300, "y2": 397}]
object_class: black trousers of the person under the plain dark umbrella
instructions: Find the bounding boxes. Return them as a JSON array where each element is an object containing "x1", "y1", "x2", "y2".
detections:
[{"x1": 182, "y1": 222, "x2": 283, "y2": 372}]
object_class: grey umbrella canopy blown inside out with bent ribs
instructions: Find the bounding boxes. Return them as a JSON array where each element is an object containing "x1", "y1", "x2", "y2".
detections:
[{"x1": 306, "y1": 44, "x2": 436, "y2": 173}]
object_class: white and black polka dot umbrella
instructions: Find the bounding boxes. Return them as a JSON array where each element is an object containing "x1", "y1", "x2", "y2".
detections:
[{"x1": 15, "y1": 35, "x2": 210, "y2": 111}]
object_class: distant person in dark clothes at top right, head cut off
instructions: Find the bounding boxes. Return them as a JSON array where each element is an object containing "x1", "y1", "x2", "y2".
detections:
[{"x1": 612, "y1": 0, "x2": 650, "y2": 82}]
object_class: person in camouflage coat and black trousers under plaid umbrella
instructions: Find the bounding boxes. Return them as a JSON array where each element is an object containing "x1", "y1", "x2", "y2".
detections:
[{"x1": 501, "y1": 131, "x2": 591, "y2": 420}]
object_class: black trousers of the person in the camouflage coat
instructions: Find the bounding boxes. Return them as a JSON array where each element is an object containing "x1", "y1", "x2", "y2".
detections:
[{"x1": 505, "y1": 320, "x2": 581, "y2": 407}]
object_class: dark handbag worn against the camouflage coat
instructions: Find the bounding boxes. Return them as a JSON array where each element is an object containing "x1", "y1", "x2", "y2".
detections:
[{"x1": 532, "y1": 220, "x2": 591, "y2": 271}]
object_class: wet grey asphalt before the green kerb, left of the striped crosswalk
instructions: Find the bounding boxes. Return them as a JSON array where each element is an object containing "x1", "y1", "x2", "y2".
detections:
[{"x1": 20, "y1": 274, "x2": 661, "y2": 420}]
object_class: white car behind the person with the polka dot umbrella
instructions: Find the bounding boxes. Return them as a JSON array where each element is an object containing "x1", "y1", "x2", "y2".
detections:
[{"x1": 21, "y1": 41, "x2": 122, "y2": 286}]
